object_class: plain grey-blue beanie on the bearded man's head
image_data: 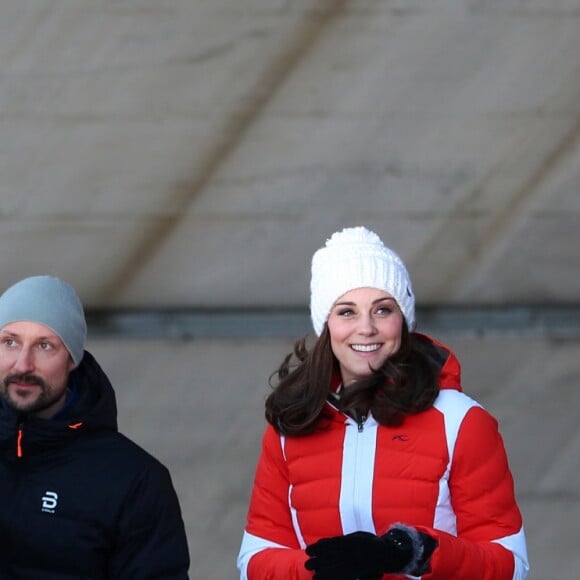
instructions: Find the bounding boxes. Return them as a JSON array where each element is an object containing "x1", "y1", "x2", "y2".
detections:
[{"x1": 0, "y1": 276, "x2": 87, "y2": 365}]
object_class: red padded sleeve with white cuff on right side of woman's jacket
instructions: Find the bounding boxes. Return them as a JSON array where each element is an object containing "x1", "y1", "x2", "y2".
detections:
[{"x1": 421, "y1": 407, "x2": 528, "y2": 580}]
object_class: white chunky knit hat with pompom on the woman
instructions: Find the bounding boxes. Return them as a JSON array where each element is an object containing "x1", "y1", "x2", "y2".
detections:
[{"x1": 310, "y1": 226, "x2": 415, "y2": 336}]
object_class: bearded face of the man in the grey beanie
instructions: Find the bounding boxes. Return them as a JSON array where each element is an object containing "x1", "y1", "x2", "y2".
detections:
[{"x1": 0, "y1": 321, "x2": 75, "y2": 419}]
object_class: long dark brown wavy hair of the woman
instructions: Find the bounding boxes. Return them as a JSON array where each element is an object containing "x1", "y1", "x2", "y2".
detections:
[{"x1": 265, "y1": 321, "x2": 439, "y2": 436}]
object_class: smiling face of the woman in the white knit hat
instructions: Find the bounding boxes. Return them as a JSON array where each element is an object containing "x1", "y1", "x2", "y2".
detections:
[{"x1": 327, "y1": 288, "x2": 403, "y2": 387}]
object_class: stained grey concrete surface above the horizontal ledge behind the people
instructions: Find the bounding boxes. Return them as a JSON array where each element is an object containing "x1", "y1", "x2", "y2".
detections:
[{"x1": 0, "y1": 0, "x2": 580, "y2": 307}]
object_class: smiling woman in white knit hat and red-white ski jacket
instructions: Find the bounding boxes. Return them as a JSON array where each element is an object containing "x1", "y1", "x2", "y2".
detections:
[{"x1": 238, "y1": 227, "x2": 529, "y2": 580}]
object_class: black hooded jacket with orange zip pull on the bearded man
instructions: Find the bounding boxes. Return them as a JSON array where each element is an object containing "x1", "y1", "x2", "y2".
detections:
[{"x1": 0, "y1": 351, "x2": 189, "y2": 580}]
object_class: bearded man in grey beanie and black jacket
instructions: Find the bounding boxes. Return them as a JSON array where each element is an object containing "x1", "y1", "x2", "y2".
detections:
[{"x1": 0, "y1": 276, "x2": 189, "y2": 580}]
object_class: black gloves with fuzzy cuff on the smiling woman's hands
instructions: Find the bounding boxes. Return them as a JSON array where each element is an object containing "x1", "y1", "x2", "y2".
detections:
[{"x1": 305, "y1": 525, "x2": 437, "y2": 580}]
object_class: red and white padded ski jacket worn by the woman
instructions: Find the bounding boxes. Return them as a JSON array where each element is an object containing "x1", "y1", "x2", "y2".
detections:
[{"x1": 238, "y1": 337, "x2": 529, "y2": 580}]
